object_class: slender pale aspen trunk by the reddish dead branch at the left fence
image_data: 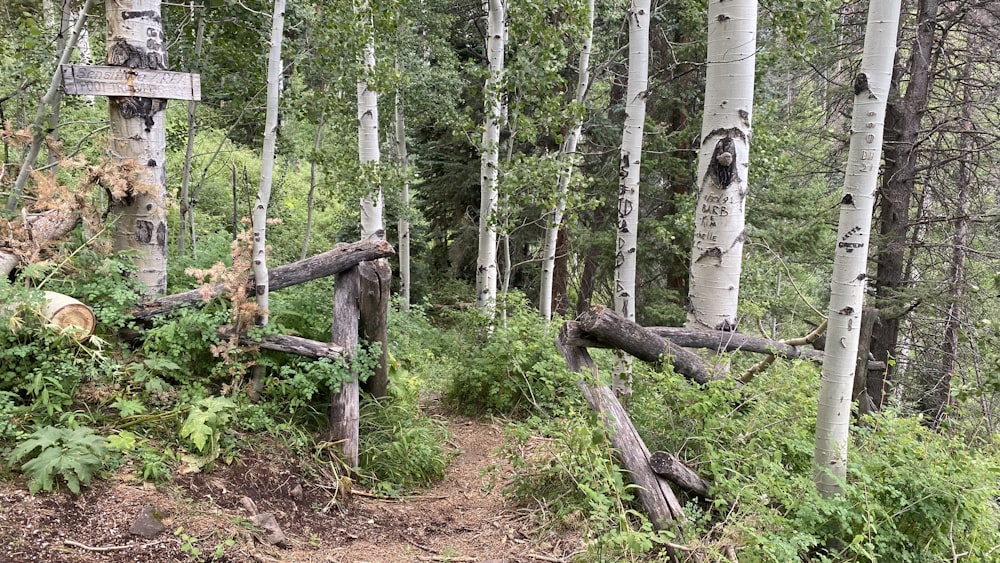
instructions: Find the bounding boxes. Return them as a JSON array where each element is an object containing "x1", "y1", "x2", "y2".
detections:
[{"x1": 251, "y1": 0, "x2": 285, "y2": 326}]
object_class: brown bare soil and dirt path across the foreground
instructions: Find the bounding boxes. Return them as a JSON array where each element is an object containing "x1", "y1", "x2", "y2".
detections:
[{"x1": 0, "y1": 415, "x2": 582, "y2": 563}]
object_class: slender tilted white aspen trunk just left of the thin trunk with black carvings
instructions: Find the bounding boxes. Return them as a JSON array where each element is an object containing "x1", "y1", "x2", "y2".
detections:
[{"x1": 538, "y1": 0, "x2": 594, "y2": 321}]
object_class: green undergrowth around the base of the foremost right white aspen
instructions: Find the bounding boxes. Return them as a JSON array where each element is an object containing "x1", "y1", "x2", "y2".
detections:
[{"x1": 630, "y1": 363, "x2": 1000, "y2": 562}]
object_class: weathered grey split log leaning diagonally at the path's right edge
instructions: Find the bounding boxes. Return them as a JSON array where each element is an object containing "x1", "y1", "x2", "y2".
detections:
[{"x1": 556, "y1": 325, "x2": 684, "y2": 530}]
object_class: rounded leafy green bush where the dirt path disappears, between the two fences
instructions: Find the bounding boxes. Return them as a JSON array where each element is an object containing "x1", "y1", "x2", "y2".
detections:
[{"x1": 443, "y1": 294, "x2": 579, "y2": 417}]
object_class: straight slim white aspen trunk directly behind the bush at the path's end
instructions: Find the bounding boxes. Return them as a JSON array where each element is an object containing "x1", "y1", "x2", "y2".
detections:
[{"x1": 476, "y1": 0, "x2": 507, "y2": 309}]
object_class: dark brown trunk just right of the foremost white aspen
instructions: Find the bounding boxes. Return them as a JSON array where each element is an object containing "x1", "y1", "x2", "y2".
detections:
[{"x1": 868, "y1": 0, "x2": 938, "y2": 409}]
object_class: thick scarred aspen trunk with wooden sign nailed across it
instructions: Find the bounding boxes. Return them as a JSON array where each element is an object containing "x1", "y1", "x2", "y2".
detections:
[{"x1": 60, "y1": 0, "x2": 201, "y2": 295}]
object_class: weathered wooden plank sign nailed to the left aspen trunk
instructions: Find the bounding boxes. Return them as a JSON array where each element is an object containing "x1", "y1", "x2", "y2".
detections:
[{"x1": 60, "y1": 65, "x2": 201, "y2": 101}]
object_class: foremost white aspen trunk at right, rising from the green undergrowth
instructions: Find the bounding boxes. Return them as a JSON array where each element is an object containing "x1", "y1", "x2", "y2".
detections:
[{"x1": 815, "y1": 0, "x2": 900, "y2": 497}]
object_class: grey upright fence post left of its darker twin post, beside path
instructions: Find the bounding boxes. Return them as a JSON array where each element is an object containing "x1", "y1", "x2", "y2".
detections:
[{"x1": 329, "y1": 268, "x2": 361, "y2": 468}]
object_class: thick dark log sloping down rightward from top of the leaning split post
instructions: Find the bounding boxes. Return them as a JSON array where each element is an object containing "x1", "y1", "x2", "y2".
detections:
[{"x1": 576, "y1": 305, "x2": 712, "y2": 384}]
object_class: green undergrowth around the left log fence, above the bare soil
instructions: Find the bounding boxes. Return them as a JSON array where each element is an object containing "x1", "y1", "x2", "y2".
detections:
[{"x1": 0, "y1": 237, "x2": 450, "y2": 495}]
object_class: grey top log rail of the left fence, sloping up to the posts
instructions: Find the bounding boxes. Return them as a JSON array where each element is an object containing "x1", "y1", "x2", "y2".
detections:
[{"x1": 132, "y1": 240, "x2": 395, "y2": 322}]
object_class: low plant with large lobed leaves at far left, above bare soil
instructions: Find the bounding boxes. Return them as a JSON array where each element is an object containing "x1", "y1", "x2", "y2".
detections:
[{"x1": 7, "y1": 426, "x2": 107, "y2": 494}]
